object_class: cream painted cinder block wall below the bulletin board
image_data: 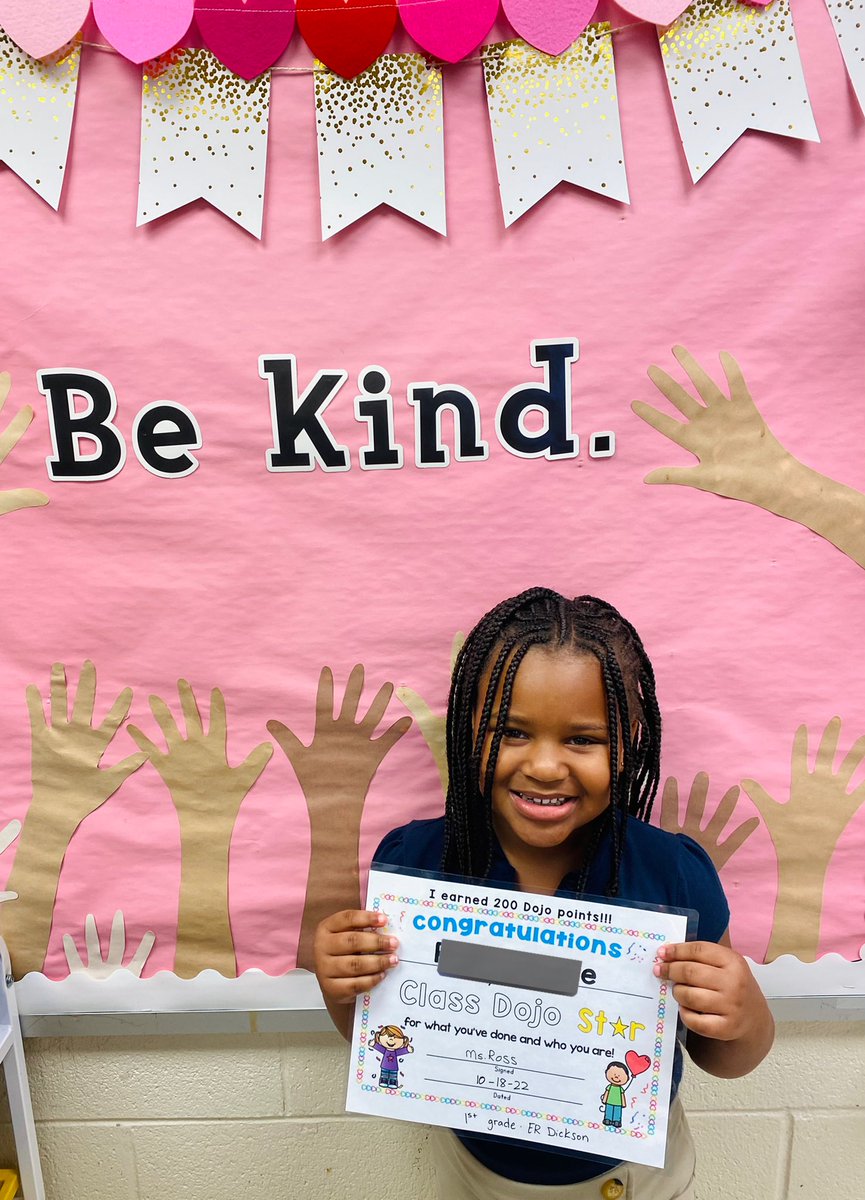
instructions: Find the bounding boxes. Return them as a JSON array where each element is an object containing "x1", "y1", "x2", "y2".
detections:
[{"x1": 0, "y1": 1022, "x2": 865, "y2": 1200}]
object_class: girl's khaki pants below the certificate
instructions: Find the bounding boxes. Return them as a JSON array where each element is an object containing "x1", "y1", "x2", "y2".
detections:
[{"x1": 432, "y1": 1097, "x2": 696, "y2": 1200}]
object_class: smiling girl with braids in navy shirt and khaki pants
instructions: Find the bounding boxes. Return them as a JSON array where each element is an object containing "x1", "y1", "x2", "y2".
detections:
[{"x1": 316, "y1": 588, "x2": 774, "y2": 1200}]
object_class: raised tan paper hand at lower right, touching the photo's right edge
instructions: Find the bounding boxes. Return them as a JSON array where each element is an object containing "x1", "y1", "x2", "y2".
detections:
[{"x1": 741, "y1": 716, "x2": 865, "y2": 962}]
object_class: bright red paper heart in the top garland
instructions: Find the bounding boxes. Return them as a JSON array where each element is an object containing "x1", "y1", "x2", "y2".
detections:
[{"x1": 298, "y1": 0, "x2": 396, "y2": 79}]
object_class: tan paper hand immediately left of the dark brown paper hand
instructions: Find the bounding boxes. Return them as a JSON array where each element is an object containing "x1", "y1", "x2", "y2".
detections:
[{"x1": 128, "y1": 679, "x2": 274, "y2": 979}]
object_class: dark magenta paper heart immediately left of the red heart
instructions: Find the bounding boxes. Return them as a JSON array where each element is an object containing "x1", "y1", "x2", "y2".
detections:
[{"x1": 196, "y1": 0, "x2": 294, "y2": 79}]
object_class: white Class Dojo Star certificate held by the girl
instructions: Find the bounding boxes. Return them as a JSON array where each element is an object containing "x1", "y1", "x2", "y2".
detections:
[{"x1": 346, "y1": 868, "x2": 689, "y2": 1166}]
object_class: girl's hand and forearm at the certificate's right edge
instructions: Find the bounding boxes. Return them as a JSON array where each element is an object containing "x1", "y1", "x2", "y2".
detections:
[{"x1": 654, "y1": 942, "x2": 775, "y2": 1079}]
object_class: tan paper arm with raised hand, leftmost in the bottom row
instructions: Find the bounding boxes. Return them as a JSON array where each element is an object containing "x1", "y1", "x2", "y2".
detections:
[{"x1": 2, "y1": 660, "x2": 146, "y2": 977}]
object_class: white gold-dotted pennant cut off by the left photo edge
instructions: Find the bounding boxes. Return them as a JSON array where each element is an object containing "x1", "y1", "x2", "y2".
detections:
[{"x1": 0, "y1": 30, "x2": 82, "y2": 209}]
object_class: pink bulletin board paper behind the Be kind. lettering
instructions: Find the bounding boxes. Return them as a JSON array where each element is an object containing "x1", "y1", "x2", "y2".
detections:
[{"x1": 0, "y1": 0, "x2": 865, "y2": 1006}]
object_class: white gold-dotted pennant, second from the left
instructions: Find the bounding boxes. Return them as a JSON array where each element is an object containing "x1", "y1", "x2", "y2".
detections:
[{"x1": 138, "y1": 49, "x2": 270, "y2": 238}]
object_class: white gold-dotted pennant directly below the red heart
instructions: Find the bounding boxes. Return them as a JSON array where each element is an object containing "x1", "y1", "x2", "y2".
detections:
[{"x1": 316, "y1": 54, "x2": 446, "y2": 240}]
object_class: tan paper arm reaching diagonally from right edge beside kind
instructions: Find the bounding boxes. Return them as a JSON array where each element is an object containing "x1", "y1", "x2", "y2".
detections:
[{"x1": 631, "y1": 346, "x2": 865, "y2": 566}]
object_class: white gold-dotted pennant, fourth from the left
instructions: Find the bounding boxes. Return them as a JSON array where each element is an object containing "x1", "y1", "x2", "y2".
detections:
[{"x1": 482, "y1": 31, "x2": 629, "y2": 226}]
